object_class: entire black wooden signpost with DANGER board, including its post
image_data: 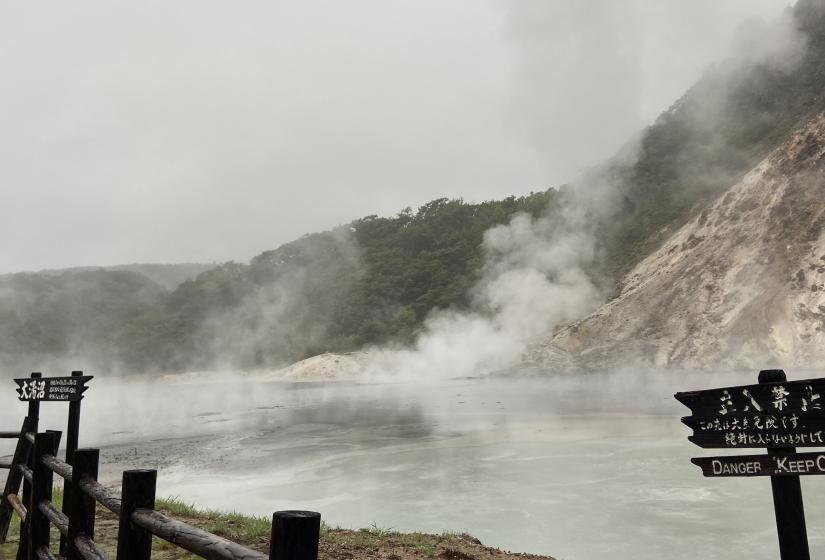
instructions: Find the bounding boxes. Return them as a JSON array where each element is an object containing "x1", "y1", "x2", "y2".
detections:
[{"x1": 674, "y1": 370, "x2": 825, "y2": 560}]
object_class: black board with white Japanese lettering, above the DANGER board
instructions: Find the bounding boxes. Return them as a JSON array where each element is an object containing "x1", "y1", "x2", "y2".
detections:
[{"x1": 674, "y1": 379, "x2": 825, "y2": 448}]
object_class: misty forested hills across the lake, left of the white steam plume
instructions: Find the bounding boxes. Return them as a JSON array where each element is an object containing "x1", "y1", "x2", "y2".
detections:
[{"x1": 0, "y1": 189, "x2": 557, "y2": 372}]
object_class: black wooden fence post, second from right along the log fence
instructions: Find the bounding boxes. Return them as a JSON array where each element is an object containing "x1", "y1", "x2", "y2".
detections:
[{"x1": 117, "y1": 469, "x2": 158, "y2": 560}]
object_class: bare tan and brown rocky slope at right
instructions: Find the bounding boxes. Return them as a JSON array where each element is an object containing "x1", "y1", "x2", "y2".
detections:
[{"x1": 527, "y1": 114, "x2": 825, "y2": 369}]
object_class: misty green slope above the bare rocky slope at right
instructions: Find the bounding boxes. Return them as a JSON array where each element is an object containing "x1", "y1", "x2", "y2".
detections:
[{"x1": 601, "y1": 0, "x2": 825, "y2": 278}]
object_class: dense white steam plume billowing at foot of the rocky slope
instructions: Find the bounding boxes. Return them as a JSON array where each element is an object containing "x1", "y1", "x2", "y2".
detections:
[{"x1": 368, "y1": 202, "x2": 600, "y2": 378}]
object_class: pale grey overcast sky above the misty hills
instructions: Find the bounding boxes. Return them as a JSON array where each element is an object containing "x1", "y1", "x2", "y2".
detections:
[{"x1": 0, "y1": 0, "x2": 789, "y2": 272}]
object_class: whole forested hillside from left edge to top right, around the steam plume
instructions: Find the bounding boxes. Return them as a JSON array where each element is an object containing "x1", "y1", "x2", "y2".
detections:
[{"x1": 0, "y1": 0, "x2": 825, "y2": 372}]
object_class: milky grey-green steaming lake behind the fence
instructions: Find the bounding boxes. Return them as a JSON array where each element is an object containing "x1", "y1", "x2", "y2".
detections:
[{"x1": 2, "y1": 374, "x2": 825, "y2": 560}]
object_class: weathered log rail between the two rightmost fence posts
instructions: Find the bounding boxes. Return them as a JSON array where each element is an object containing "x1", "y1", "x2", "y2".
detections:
[{"x1": 132, "y1": 510, "x2": 266, "y2": 560}]
